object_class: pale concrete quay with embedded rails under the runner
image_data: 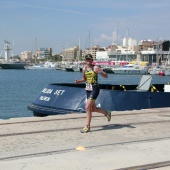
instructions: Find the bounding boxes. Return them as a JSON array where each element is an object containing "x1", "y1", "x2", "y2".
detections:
[{"x1": 0, "y1": 108, "x2": 170, "y2": 170}]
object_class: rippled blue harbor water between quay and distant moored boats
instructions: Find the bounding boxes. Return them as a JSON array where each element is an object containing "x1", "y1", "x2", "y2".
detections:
[{"x1": 0, "y1": 69, "x2": 170, "y2": 119}]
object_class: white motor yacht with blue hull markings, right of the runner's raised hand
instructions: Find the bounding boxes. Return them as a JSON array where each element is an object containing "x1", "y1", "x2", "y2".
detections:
[{"x1": 112, "y1": 64, "x2": 148, "y2": 74}]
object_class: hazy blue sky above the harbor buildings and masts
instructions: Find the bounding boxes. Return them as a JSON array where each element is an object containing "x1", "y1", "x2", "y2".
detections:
[{"x1": 0, "y1": 0, "x2": 170, "y2": 55}]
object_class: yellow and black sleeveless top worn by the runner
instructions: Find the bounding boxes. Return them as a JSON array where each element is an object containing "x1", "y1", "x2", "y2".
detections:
[{"x1": 84, "y1": 67, "x2": 98, "y2": 84}]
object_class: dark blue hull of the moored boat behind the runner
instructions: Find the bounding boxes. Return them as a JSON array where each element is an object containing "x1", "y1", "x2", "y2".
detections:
[{"x1": 27, "y1": 84, "x2": 170, "y2": 116}]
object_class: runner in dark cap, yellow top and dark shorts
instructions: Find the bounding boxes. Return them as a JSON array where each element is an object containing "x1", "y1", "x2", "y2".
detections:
[{"x1": 75, "y1": 54, "x2": 111, "y2": 133}]
